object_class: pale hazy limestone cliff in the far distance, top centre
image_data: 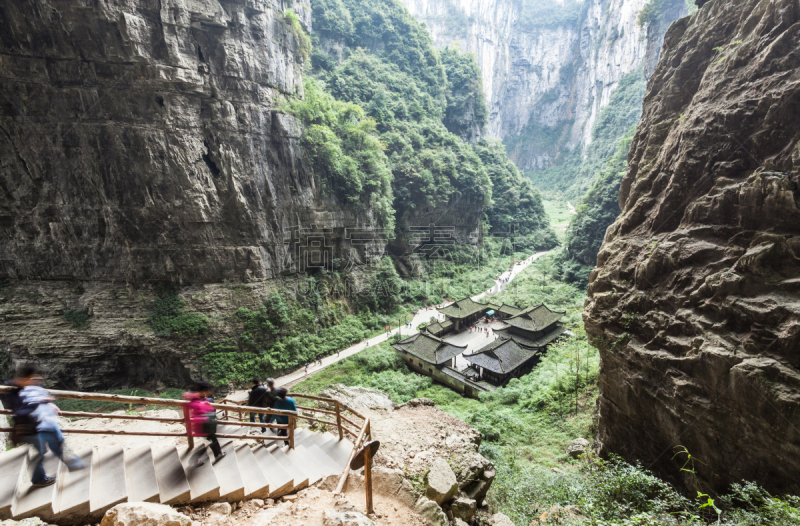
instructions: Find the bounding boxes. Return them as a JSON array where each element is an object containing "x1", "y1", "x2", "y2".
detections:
[{"x1": 396, "y1": 0, "x2": 686, "y2": 170}]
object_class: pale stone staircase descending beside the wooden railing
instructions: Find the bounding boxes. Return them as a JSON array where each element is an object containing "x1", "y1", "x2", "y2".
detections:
[{"x1": 0, "y1": 432, "x2": 353, "y2": 523}]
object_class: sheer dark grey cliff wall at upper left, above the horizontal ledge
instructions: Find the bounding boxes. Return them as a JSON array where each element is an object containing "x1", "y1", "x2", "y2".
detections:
[{"x1": 0, "y1": 0, "x2": 384, "y2": 283}]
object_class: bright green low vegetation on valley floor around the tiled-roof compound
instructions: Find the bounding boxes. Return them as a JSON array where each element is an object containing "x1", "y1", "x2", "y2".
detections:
[{"x1": 294, "y1": 256, "x2": 800, "y2": 526}]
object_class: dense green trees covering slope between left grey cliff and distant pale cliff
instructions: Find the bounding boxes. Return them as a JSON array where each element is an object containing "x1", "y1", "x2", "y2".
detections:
[{"x1": 296, "y1": 0, "x2": 556, "y2": 248}]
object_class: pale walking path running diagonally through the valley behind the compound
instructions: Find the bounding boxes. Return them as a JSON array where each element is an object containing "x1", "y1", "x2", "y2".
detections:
[{"x1": 225, "y1": 250, "x2": 550, "y2": 402}]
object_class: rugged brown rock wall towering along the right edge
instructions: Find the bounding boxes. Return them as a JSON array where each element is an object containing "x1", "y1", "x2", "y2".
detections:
[{"x1": 584, "y1": 0, "x2": 800, "y2": 500}]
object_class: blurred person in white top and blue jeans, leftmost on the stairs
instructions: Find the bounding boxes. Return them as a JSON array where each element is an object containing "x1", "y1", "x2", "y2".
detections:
[{"x1": 4, "y1": 365, "x2": 86, "y2": 487}]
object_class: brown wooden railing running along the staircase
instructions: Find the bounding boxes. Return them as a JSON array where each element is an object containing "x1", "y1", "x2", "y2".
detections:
[{"x1": 0, "y1": 386, "x2": 369, "y2": 460}]
